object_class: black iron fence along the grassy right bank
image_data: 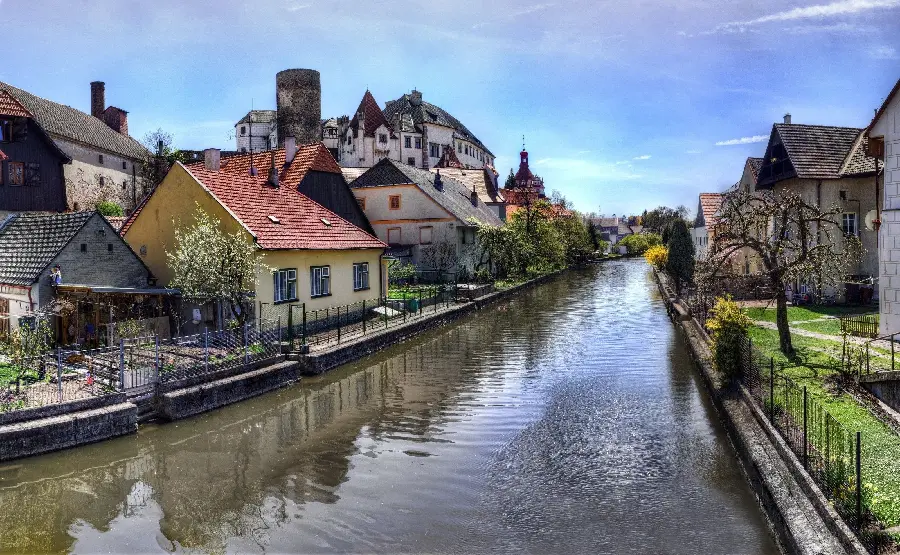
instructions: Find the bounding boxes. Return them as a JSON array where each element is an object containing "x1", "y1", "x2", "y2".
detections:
[{"x1": 740, "y1": 341, "x2": 888, "y2": 553}]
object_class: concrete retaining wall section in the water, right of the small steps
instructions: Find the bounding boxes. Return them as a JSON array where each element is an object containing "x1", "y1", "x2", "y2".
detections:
[{"x1": 156, "y1": 361, "x2": 299, "y2": 420}]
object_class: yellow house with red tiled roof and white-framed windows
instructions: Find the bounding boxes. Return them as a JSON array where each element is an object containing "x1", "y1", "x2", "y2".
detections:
[{"x1": 121, "y1": 141, "x2": 387, "y2": 326}]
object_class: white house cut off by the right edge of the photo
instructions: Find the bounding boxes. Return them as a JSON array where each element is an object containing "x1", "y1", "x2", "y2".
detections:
[{"x1": 865, "y1": 80, "x2": 900, "y2": 335}]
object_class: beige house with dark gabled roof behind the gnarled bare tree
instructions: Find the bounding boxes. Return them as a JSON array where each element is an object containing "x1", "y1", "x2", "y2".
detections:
[{"x1": 756, "y1": 114, "x2": 882, "y2": 302}]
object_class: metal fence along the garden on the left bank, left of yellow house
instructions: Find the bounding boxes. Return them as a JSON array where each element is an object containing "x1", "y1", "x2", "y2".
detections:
[{"x1": 0, "y1": 320, "x2": 285, "y2": 413}]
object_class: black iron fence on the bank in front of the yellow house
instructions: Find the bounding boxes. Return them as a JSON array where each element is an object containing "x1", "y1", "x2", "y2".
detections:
[{"x1": 283, "y1": 284, "x2": 459, "y2": 350}]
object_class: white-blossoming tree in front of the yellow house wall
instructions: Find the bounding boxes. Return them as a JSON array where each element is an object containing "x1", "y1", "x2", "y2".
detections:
[{"x1": 166, "y1": 205, "x2": 264, "y2": 326}]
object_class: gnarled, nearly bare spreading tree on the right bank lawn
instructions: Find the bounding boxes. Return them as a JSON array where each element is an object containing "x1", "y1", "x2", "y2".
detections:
[{"x1": 698, "y1": 190, "x2": 863, "y2": 355}]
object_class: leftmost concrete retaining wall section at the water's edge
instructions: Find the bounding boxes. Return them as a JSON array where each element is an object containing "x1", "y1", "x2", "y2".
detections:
[{"x1": 0, "y1": 403, "x2": 137, "y2": 461}]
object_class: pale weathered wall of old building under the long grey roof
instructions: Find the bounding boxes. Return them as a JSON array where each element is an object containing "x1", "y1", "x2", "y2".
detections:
[{"x1": 54, "y1": 137, "x2": 143, "y2": 211}]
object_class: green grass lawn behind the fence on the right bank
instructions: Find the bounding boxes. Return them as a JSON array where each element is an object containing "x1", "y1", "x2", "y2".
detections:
[{"x1": 750, "y1": 327, "x2": 900, "y2": 527}]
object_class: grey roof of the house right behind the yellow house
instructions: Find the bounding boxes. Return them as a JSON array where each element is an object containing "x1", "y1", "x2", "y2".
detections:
[{"x1": 350, "y1": 158, "x2": 503, "y2": 226}]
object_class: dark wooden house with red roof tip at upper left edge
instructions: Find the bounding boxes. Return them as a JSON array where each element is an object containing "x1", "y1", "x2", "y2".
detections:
[{"x1": 0, "y1": 90, "x2": 71, "y2": 216}]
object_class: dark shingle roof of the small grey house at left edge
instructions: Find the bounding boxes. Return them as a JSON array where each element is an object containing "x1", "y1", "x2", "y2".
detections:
[{"x1": 0, "y1": 212, "x2": 96, "y2": 286}]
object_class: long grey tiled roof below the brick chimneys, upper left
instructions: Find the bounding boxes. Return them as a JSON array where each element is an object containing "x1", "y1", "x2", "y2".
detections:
[{"x1": 0, "y1": 82, "x2": 148, "y2": 159}]
